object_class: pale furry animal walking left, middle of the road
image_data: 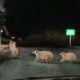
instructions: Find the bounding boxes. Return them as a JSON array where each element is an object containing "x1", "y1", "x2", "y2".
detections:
[{"x1": 32, "y1": 50, "x2": 54, "y2": 62}]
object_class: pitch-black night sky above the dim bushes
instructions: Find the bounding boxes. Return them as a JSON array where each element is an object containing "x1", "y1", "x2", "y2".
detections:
[{"x1": 4, "y1": 0, "x2": 80, "y2": 35}]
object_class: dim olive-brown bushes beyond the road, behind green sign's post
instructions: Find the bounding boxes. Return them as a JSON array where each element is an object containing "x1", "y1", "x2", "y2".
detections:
[{"x1": 16, "y1": 30, "x2": 80, "y2": 46}]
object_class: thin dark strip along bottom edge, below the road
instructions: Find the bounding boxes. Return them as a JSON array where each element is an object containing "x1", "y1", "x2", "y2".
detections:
[{"x1": 15, "y1": 76, "x2": 80, "y2": 80}]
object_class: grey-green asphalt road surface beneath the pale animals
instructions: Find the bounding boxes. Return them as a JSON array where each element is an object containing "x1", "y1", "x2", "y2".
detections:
[{"x1": 0, "y1": 47, "x2": 80, "y2": 80}]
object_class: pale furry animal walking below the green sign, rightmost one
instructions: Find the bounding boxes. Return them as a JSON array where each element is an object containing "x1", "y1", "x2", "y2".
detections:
[{"x1": 60, "y1": 52, "x2": 77, "y2": 63}]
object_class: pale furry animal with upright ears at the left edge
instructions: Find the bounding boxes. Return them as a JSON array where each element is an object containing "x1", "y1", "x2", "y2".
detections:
[{"x1": 0, "y1": 41, "x2": 20, "y2": 59}]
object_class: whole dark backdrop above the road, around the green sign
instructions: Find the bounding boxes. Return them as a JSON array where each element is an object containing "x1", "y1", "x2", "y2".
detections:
[{"x1": 0, "y1": 0, "x2": 80, "y2": 45}]
